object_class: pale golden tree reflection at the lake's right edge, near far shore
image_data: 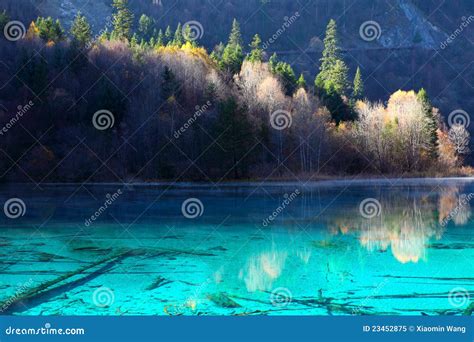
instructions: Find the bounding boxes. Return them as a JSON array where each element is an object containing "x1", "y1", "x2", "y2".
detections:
[{"x1": 333, "y1": 187, "x2": 471, "y2": 263}]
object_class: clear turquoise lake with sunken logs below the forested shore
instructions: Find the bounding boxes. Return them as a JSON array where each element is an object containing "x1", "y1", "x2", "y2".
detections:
[{"x1": 0, "y1": 179, "x2": 474, "y2": 315}]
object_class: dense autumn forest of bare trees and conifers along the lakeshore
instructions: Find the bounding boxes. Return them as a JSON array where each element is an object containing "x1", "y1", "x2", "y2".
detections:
[{"x1": 0, "y1": 0, "x2": 469, "y2": 183}]
